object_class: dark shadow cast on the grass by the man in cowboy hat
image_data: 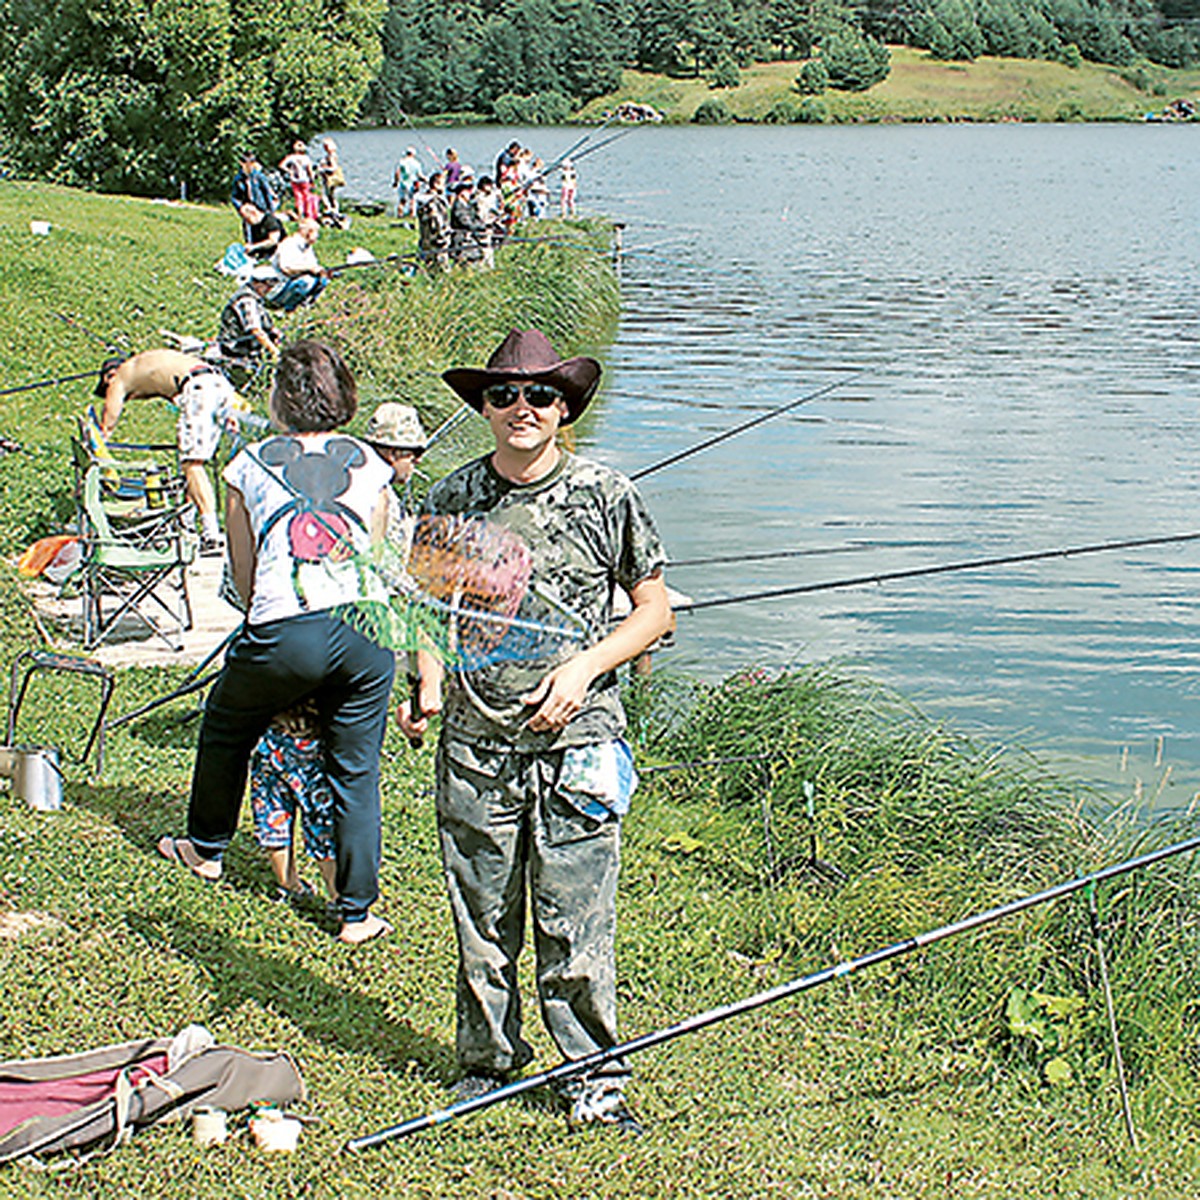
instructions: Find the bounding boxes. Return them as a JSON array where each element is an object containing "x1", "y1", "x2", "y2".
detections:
[{"x1": 126, "y1": 912, "x2": 452, "y2": 1085}]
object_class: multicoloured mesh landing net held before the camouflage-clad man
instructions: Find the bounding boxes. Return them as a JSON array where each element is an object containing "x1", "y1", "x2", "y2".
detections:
[{"x1": 338, "y1": 515, "x2": 584, "y2": 671}]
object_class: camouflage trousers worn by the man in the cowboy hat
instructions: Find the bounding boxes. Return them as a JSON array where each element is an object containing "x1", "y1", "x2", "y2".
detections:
[{"x1": 437, "y1": 737, "x2": 629, "y2": 1094}]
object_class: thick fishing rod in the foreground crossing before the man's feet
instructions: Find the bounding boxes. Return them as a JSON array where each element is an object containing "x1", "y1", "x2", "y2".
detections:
[{"x1": 343, "y1": 838, "x2": 1200, "y2": 1151}]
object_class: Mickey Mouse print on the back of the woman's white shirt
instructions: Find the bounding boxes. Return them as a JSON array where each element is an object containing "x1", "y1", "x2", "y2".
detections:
[{"x1": 260, "y1": 438, "x2": 366, "y2": 608}]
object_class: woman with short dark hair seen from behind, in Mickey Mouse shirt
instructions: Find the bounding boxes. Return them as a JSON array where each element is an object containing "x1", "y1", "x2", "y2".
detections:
[{"x1": 158, "y1": 341, "x2": 394, "y2": 944}]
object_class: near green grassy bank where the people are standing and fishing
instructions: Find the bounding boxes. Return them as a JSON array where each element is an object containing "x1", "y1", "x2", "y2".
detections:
[{"x1": 0, "y1": 186, "x2": 1200, "y2": 1200}]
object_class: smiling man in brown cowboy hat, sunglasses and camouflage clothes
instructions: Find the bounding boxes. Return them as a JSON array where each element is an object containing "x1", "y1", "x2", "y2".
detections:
[{"x1": 398, "y1": 329, "x2": 671, "y2": 1133}]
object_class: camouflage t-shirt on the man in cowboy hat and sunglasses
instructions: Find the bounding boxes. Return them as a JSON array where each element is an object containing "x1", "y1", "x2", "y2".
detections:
[{"x1": 425, "y1": 451, "x2": 666, "y2": 751}]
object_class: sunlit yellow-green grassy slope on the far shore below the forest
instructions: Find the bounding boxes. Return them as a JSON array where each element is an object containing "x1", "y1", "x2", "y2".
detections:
[{"x1": 583, "y1": 46, "x2": 1200, "y2": 122}]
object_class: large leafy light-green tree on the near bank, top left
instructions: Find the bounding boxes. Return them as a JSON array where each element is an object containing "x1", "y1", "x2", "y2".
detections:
[{"x1": 0, "y1": 0, "x2": 384, "y2": 194}]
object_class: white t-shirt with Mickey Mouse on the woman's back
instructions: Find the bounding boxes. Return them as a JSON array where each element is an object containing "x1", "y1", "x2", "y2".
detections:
[{"x1": 223, "y1": 431, "x2": 391, "y2": 625}]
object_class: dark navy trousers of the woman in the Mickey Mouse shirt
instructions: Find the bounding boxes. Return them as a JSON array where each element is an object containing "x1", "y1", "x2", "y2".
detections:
[{"x1": 187, "y1": 612, "x2": 395, "y2": 922}]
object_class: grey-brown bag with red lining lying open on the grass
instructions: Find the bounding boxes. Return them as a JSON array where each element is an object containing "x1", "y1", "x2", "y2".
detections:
[{"x1": 0, "y1": 1025, "x2": 305, "y2": 1164}]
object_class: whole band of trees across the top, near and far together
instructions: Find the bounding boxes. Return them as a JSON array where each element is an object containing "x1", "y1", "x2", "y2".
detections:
[{"x1": 0, "y1": 0, "x2": 1200, "y2": 196}]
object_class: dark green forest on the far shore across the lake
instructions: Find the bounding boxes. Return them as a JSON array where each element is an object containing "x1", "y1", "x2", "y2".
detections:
[{"x1": 366, "y1": 0, "x2": 1200, "y2": 122}]
